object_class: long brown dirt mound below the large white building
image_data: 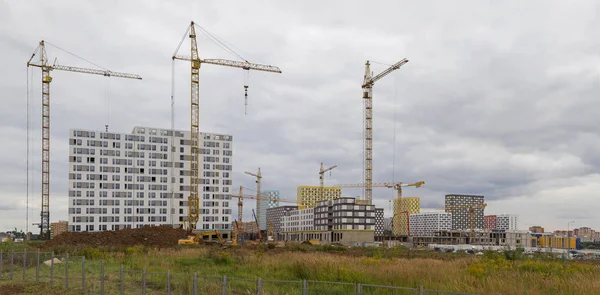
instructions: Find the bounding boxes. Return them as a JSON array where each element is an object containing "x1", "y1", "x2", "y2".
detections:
[{"x1": 43, "y1": 226, "x2": 187, "y2": 248}]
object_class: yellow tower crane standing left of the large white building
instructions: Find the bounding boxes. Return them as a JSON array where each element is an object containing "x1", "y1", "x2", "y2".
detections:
[{"x1": 27, "y1": 40, "x2": 142, "y2": 240}]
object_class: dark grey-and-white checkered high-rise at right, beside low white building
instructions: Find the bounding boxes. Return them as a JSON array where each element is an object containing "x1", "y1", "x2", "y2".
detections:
[{"x1": 445, "y1": 194, "x2": 484, "y2": 230}]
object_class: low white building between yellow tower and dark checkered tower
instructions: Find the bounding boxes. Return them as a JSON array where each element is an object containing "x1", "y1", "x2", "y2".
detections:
[{"x1": 409, "y1": 212, "x2": 452, "y2": 236}]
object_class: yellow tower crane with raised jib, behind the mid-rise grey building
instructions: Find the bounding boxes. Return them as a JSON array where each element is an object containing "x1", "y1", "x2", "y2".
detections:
[{"x1": 362, "y1": 58, "x2": 408, "y2": 204}]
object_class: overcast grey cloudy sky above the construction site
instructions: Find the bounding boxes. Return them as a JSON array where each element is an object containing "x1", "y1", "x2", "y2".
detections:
[{"x1": 0, "y1": 0, "x2": 600, "y2": 232}]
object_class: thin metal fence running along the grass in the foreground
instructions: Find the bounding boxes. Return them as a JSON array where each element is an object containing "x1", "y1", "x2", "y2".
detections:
[{"x1": 0, "y1": 250, "x2": 478, "y2": 295}]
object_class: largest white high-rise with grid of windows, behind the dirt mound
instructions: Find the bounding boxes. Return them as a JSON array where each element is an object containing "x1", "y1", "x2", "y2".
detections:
[{"x1": 69, "y1": 127, "x2": 233, "y2": 237}]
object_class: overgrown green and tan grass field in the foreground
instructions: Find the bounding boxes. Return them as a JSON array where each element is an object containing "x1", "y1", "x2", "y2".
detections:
[{"x1": 4, "y1": 245, "x2": 600, "y2": 295}]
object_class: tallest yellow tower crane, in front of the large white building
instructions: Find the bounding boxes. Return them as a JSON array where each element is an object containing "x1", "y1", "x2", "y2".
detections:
[{"x1": 172, "y1": 21, "x2": 281, "y2": 229}]
